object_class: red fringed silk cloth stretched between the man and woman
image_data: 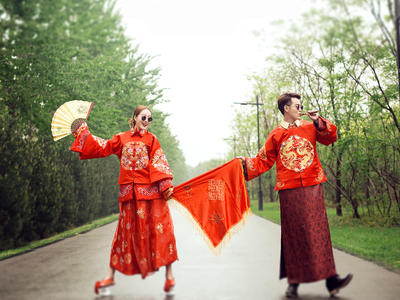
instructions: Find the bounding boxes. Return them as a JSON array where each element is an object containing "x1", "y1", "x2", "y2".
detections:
[{"x1": 174, "y1": 159, "x2": 250, "y2": 248}]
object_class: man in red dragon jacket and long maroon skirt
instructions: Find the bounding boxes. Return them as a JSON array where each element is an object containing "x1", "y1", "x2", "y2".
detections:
[{"x1": 244, "y1": 93, "x2": 353, "y2": 298}]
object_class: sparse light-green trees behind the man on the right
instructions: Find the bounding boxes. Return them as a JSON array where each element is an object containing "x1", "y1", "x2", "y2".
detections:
[{"x1": 230, "y1": 0, "x2": 400, "y2": 223}]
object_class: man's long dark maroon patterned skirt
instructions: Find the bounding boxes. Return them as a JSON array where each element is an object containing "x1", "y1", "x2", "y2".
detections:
[{"x1": 279, "y1": 184, "x2": 336, "y2": 283}]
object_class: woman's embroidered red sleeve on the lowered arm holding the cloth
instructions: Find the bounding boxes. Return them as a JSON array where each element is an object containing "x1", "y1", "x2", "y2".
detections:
[{"x1": 150, "y1": 136, "x2": 173, "y2": 182}]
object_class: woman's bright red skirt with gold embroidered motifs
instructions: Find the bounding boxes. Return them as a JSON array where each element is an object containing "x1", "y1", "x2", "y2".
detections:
[{"x1": 110, "y1": 199, "x2": 178, "y2": 278}]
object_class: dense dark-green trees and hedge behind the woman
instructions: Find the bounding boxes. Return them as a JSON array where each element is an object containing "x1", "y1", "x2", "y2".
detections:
[{"x1": 0, "y1": 0, "x2": 186, "y2": 249}]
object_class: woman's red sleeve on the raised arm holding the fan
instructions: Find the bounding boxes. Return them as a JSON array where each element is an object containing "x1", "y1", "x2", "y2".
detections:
[{"x1": 71, "y1": 124, "x2": 121, "y2": 159}]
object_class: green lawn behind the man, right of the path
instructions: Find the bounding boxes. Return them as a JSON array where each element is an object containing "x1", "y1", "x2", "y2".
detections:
[{"x1": 251, "y1": 201, "x2": 400, "y2": 273}]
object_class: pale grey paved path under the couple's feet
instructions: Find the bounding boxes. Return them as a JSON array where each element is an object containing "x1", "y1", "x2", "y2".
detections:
[{"x1": 0, "y1": 208, "x2": 400, "y2": 300}]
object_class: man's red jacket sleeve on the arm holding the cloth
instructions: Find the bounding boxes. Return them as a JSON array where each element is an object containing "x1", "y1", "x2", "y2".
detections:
[{"x1": 246, "y1": 133, "x2": 276, "y2": 180}]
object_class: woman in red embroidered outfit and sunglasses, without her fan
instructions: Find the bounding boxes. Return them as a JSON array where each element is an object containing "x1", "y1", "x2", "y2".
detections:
[{"x1": 71, "y1": 105, "x2": 178, "y2": 294}]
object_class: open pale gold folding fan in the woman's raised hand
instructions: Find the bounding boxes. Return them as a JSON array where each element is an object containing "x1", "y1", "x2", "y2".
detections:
[{"x1": 51, "y1": 100, "x2": 94, "y2": 141}]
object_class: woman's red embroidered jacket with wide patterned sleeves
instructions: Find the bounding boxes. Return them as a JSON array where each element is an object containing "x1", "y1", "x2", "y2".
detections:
[{"x1": 71, "y1": 124, "x2": 173, "y2": 201}]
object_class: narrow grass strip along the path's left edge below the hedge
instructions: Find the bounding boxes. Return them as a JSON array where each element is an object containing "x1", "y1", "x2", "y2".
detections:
[{"x1": 0, "y1": 214, "x2": 118, "y2": 260}]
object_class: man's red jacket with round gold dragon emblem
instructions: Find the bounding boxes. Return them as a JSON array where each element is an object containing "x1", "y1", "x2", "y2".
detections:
[{"x1": 245, "y1": 117, "x2": 337, "y2": 190}]
